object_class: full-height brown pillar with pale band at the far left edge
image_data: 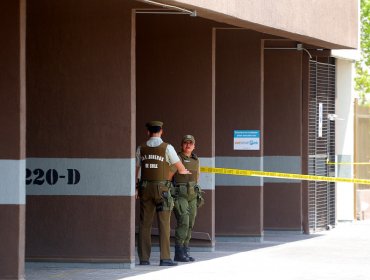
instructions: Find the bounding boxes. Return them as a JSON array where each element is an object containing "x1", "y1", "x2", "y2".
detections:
[{"x1": 0, "y1": 0, "x2": 26, "y2": 279}]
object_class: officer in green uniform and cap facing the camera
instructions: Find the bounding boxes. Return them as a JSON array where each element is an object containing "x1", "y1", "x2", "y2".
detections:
[{"x1": 171, "y1": 135, "x2": 204, "y2": 262}]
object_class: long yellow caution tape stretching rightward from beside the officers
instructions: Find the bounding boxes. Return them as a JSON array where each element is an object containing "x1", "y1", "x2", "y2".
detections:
[{"x1": 200, "y1": 166, "x2": 370, "y2": 185}]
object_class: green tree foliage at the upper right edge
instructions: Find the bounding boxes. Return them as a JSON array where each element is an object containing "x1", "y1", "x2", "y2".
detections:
[{"x1": 355, "y1": 0, "x2": 370, "y2": 104}]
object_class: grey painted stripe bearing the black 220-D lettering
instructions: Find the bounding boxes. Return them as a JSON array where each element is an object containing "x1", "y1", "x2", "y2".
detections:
[{"x1": 26, "y1": 158, "x2": 135, "y2": 196}]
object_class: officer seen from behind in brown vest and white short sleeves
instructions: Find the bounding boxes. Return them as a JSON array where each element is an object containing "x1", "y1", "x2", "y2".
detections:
[{"x1": 136, "y1": 121, "x2": 189, "y2": 266}]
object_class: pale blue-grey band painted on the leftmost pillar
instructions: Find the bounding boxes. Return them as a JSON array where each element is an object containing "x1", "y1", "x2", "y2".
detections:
[{"x1": 0, "y1": 159, "x2": 26, "y2": 204}]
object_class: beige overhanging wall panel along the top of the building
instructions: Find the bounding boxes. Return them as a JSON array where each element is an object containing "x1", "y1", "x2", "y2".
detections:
[{"x1": 161, "y1": 0, "x2": 359, "y2": 48}]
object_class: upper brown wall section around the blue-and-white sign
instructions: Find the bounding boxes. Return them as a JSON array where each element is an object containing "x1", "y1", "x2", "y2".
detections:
[{"x1": 216, "y1": 29, "x2": 263, "y2": 157}]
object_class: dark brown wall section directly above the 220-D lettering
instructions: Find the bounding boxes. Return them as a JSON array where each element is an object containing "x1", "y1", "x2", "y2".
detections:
[{"x1": 27, "y1": 0, "x2": 135, "y2": 158}]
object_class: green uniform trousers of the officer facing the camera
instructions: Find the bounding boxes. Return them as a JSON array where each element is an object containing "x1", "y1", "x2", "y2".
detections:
[{"x1": 174, "y1": 186, "x2": 197, "y2": 247}]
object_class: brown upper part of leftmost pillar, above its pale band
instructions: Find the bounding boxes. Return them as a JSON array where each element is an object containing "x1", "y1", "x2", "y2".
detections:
[{"x1": 0, "y1": 0, "x2": 26, "y2": 159}]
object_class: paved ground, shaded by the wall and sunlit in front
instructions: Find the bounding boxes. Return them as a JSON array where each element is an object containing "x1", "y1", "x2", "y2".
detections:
[{"x1": 26, "y1": 221, "x2": 370, "y2": 280}]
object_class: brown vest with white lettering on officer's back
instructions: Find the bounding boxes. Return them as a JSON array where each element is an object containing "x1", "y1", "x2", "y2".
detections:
[{"x1": 140, "y1": 142, "x2": 170, "y2": 181}]
